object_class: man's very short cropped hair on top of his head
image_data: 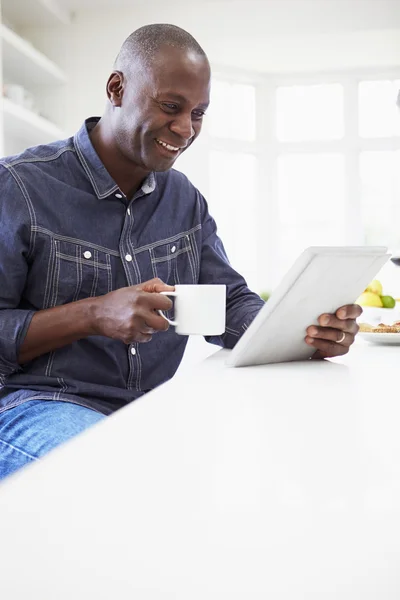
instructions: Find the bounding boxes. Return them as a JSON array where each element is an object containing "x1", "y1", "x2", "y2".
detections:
[{"x1": 114, "y1": 23, "x2": 207, "y2": 70}]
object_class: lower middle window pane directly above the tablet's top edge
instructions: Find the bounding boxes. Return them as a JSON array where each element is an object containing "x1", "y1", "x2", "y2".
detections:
[{"x1": 278, "y1": 154, "x2": 346, "y2": 276}]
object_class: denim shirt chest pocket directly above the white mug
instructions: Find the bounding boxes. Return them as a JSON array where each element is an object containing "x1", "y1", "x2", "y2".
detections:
[{"x1": 149, "y1": 235, "x2": 199, "y2": 285}]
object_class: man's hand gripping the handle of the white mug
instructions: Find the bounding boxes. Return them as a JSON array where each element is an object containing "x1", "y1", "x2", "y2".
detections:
[{"x1": 91, "y1": 278, "x2": 174, "y2": 344}]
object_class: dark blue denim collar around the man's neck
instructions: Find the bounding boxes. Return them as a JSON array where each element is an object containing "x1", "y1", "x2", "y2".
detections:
[{"x1": 74, "y1": 117, "x2": 156, "y2": 199}]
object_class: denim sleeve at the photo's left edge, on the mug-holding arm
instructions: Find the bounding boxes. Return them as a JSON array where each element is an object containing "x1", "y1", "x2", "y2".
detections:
[{"x1": 0, "y1": 164, "x2": 34, "y2": 384}]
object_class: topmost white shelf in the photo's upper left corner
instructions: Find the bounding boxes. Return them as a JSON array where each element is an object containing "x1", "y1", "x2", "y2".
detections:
[{"x1": 1, "y1": 0, "x2": 71, "y2": 27}]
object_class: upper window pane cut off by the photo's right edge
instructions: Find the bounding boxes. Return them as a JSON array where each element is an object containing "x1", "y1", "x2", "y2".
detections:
[{"x1": 358, "y1": 79, "x2": 400, "y2": 138}]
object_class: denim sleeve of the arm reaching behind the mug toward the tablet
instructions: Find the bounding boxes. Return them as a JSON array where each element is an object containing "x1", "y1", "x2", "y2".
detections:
[{"x1": 199, "y1": 196, "x2": 265, "y2": 348}]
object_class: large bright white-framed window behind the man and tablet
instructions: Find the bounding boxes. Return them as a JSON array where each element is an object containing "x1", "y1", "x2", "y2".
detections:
[{"x1": 178, "y1": 69, "x2": 400, "y2": 297}]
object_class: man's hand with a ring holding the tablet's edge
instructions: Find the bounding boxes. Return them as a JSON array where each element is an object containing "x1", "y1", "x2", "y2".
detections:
[{"x1": 305, "y1": 304, "x2": 362, "y2": 358}]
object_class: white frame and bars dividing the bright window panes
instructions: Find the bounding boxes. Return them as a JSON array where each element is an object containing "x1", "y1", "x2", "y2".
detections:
[{"x1": 192, "y1": 66, "x2": 400, "y2": 291}]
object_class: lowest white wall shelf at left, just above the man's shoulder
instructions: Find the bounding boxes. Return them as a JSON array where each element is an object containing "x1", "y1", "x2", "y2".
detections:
[{"x1": 0, "y1": 98, "x2": 64, "y2": 147}]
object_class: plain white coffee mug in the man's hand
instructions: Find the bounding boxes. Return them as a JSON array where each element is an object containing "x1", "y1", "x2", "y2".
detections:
[{"x1": 158, "y1": 284, "x2": 226, "y2": 335}]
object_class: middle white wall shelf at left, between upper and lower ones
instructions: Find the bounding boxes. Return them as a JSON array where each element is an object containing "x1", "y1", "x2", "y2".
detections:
[{"x1": 0, "y1": 25, "x2": 66, "y2": 87}]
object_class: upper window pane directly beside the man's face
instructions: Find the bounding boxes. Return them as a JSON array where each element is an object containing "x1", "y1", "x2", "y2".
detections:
[{"x1": 207, "y1": 80, "x2": 256, "y2": 142}]
